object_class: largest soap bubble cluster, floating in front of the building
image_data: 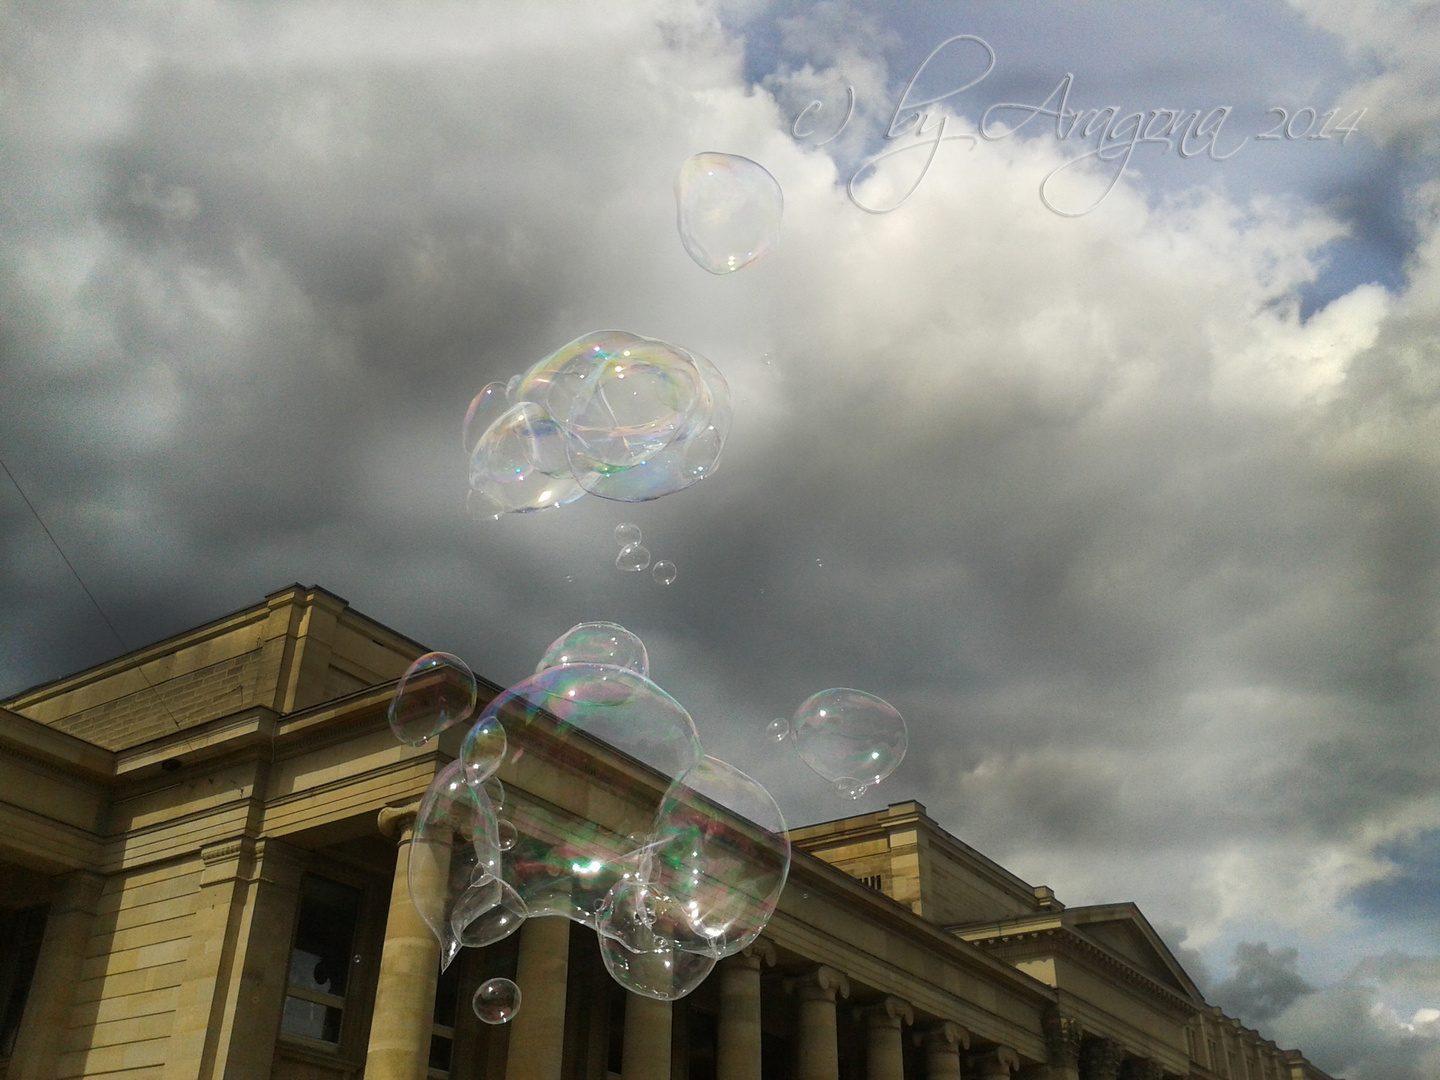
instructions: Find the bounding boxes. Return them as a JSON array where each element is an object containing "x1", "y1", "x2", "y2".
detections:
[{"x1": 390, "y1": 622, "x2": 791, "y2": 1020}]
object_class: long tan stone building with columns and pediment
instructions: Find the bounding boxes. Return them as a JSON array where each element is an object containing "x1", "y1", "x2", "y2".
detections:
[{"x1": 0, "y1": 585, "x2": 1325, "y2": 1080}]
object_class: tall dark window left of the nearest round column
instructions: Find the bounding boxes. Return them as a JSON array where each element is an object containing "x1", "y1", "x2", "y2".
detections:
[{"x1": 279, "y1": 874, "x2": 360, "y2": 1047}]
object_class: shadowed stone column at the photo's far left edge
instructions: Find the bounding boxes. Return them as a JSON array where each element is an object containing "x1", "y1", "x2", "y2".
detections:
[{"x1": 7, "y1": 870, "x2": 105, "y2": 1080}]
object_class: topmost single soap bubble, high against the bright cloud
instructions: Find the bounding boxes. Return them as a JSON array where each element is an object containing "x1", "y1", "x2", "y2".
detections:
[{"x1": 675, "y1": 153, "x2": 785, "y2": 274}]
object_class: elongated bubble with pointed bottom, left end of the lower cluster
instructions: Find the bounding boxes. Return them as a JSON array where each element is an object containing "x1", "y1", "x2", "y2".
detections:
[{"x1": 408, "y1": 762, "x2": 501, "y2": 969}]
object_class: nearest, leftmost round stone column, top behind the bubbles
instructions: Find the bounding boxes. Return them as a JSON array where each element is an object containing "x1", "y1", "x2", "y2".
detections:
[{"x1": 364, "y1": 805, "x2": 449, "y2": 1080}]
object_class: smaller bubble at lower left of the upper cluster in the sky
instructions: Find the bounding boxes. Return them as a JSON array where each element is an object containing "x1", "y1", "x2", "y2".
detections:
[{"x1": 469, "y1": 402, "x2": 585, "y2": 514}]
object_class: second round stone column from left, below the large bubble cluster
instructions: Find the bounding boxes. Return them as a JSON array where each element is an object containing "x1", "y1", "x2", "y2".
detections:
[{"x1": 506, "y1": 914, "x2": 570, "y2": 1080}]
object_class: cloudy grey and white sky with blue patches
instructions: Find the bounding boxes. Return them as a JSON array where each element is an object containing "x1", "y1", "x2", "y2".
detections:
[{"x1": 0, "y1": 0, "x2": 1440, "y2": 1080}]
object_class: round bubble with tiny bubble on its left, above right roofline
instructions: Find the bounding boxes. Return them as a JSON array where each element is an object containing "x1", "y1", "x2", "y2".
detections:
[{"x1": 765, "y1": 687, "x2": 909, "y2": 799}]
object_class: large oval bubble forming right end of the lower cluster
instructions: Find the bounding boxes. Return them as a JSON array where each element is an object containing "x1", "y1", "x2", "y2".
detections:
[{"x1": 647, "y1": 757, "x2": 791, "y2": 956}]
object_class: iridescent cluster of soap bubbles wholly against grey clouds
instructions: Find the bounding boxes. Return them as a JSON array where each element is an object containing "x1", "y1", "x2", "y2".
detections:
[{"x1": 462, "y1": 330, "x2": 732, "y2": 520}]
